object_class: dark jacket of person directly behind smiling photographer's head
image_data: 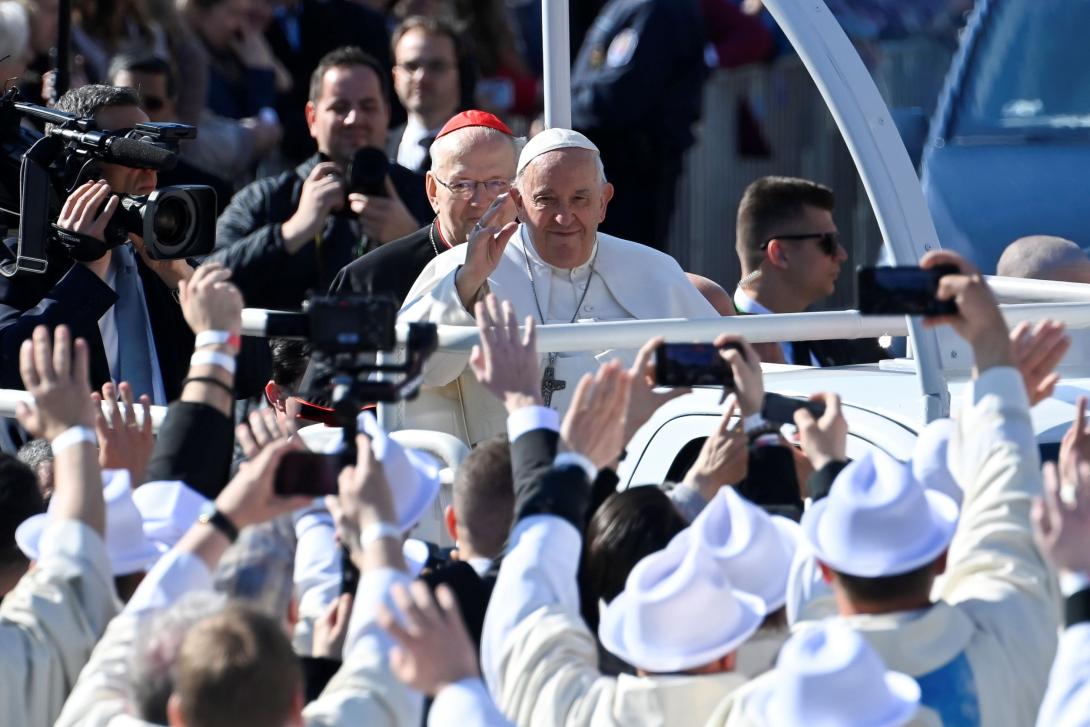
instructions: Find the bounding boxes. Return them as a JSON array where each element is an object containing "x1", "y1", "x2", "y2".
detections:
[{"x1": 265, "y1": 0, "x2": 390, "y2": 163}]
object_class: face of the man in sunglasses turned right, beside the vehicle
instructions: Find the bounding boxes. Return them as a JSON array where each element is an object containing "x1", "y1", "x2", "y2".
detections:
[{"x1": 776, "y1": 206, "x2": 848, "y2": 305}]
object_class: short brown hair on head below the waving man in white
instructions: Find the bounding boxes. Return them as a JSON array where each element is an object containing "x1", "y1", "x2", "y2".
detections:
[{"x1": 452, "y1": 435, "x2": 514, "y2": 558}]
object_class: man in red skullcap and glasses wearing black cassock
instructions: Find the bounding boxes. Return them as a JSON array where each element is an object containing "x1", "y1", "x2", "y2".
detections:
[{"x1": 330, "y1": 110, "x2": 521, "y2": 305}]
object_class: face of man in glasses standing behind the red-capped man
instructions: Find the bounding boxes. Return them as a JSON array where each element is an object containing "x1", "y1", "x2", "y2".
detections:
[{"x1": 393, "y1": 28, "x2": 459, "y2": 123}]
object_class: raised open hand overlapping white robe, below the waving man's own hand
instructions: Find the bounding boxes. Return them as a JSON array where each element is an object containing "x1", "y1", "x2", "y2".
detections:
[{"x1": 470, "y1": 294, "x2": 541, "y2": 413}]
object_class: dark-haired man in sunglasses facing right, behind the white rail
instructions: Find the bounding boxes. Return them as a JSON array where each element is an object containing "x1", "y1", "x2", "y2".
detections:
[{"x1": 735, "y1": 177, "x2": 889, "y2": 366}]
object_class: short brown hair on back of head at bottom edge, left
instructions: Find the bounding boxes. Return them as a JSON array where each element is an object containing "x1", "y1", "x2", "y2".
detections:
[{"x1": 174, "y1": 605, "x2": 303, "y2": 727}]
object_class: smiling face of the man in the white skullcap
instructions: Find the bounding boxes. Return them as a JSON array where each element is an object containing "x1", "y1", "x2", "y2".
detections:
[{"x1": 511, "y1": 149, "x2": 613, "y2": 268}]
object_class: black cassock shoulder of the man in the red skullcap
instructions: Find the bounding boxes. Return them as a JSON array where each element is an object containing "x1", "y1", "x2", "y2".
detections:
[{"x1": 329, "y1": 222, "x2": 446, "y2": 307}]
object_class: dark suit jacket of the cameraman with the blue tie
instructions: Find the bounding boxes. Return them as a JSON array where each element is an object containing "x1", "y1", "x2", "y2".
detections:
[{"x1": 0, "y1": 239, "x2": 193, "y2": 400}]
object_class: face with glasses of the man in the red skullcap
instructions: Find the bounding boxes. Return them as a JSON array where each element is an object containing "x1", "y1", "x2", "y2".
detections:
[{"x1": 427, "y1": 135, "x2": 518, "y2": 244}]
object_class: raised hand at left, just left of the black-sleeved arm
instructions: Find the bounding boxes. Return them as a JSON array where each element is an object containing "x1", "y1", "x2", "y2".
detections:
[{"x1": 90, "y1": 381, "x2": 155, "y2": 487}]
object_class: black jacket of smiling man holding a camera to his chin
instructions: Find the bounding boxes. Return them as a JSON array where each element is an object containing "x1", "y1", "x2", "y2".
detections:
[{"x1": 206, "y1": 155, "x2": 433, "y2": 311}]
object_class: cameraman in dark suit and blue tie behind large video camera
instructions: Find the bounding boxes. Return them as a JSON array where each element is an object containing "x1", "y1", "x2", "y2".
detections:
[{"x1": 0, "y1": 85, "x2": 193, "y2": 404}]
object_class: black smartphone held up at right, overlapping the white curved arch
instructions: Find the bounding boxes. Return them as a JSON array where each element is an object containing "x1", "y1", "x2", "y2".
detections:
[{"x1": 856, "y1": 265, "x2": 959, "y2": 316}]
